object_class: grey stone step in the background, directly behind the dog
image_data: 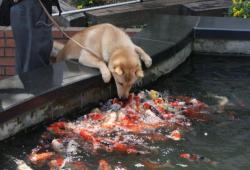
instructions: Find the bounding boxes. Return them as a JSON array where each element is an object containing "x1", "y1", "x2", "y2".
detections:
[{"x1": 86, "y1": 0, "x2": 231, "y2": 27}]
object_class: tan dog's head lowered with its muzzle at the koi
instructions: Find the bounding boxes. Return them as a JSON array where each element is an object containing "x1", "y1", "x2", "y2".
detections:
[{"x1": 109, "y1": 48, "x2": 144, "y2": 98}]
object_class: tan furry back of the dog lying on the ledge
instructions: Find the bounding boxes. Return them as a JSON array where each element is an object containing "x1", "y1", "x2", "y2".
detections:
[{"x1": 54, "y1": 24, "x2": 133, "y2": 62}]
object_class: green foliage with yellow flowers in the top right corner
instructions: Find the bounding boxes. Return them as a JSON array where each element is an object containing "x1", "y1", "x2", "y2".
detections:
[{"x1": 228, "y1": 0, "x2": 250, "y2": 18}]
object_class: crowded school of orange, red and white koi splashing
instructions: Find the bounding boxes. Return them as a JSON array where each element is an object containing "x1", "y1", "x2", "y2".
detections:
[{"x1": 28, "y1": 90, "x2": 215, "y2": 170}]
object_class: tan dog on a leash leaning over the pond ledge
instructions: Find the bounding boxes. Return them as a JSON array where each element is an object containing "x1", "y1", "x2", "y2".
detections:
[{"x1": 57, "y1": 23, "x2": 152, "y2": 98}]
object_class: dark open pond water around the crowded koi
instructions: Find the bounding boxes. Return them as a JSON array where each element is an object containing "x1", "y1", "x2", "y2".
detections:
[{"x1": 0, "y1": 55, "x2": 250, "y2": 170}]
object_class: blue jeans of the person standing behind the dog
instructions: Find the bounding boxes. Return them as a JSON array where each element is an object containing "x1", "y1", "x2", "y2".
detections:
[{"x1": 10, "y1": 0, "x2": 53, "y2": 74}]
